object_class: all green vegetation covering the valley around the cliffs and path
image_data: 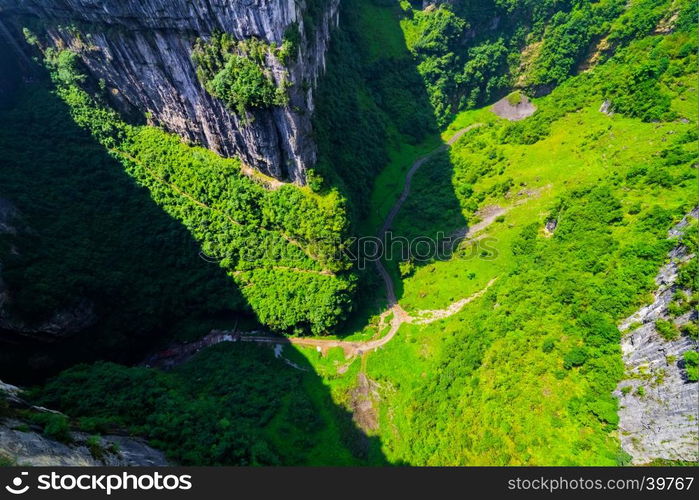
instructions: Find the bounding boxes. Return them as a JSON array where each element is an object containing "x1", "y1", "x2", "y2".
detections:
[{"x1": 0, "y1": 0, "x2": 698, "y2": 465}]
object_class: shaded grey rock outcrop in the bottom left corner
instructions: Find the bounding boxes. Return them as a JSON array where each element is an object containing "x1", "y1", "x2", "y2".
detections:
[{"x1": 0, "y1": 381, "x2": 169, "y2": 467}]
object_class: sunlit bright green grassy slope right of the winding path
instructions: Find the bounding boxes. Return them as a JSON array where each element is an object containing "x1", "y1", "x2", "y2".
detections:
[{"x1": 298, "y1": 1, "x2": 697, "y2": 465}]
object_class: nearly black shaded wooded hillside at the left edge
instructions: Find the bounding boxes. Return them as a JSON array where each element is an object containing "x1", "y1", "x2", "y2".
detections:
[{"x1": 0, "y1": 79, "x2": 248, "y2": 378}]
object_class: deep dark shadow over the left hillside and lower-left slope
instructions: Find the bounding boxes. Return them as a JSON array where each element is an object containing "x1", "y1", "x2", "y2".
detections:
[{"x1": 0, "y1": 42, "x2": 386, "y2": 465}]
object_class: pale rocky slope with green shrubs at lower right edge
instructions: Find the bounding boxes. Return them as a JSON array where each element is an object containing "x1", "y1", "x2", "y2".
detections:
[{"x1": 615, "y1": 208, "x2": 699, "y2": 464}]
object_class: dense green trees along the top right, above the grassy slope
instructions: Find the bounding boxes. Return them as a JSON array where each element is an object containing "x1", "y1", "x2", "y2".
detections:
[{"x1": 401, "y1": 0, "x2": 696, "y2": 125}]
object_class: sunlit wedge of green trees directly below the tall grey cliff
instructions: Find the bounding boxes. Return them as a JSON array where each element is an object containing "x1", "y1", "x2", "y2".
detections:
[{"x1": 30, "y1": 49, "x2": 354, "y2": 334}]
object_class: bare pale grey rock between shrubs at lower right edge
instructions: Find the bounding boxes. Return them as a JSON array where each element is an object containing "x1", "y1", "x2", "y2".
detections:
[{"x1": 614, "y1": 209, "x2": 699, "y2": 464}]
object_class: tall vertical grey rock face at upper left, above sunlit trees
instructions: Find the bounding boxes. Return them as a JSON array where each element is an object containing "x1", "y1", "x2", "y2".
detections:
[{"x1": 0, "y1": 0, "x2": 340, "y2": 183}]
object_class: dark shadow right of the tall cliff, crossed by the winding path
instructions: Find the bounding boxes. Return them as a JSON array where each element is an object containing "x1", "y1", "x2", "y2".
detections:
[{"x1": 314, "y1": 0, "x2": 466, "y2": 336}]
